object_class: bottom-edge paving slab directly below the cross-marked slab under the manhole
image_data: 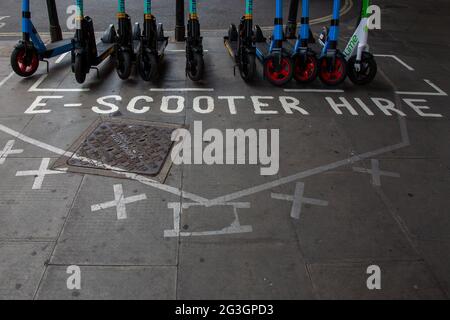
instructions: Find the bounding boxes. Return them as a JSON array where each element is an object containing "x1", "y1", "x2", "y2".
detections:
[{"x1": 36, "y1": 266, "x2": 177, "y2": 300}]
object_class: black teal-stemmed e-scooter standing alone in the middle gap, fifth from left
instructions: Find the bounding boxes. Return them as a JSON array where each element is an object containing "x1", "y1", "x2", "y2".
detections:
[{"x1": 186, "y1": 0, "x2": 205, "y2": 81}]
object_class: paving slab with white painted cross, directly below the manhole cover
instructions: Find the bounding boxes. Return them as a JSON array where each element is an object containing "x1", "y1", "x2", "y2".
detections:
[{"x1": 51, "y1": 176, "x2": 179, "y2": 266}]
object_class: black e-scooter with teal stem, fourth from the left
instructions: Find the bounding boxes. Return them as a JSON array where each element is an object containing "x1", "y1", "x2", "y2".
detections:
[{"x1": 133, "y1": 0, "x2": 169, "y2": 81}]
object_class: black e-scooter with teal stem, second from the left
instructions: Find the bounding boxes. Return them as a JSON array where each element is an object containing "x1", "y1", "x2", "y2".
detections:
[{"x1": 72, "y1": 0, "x2": 117, "y2": 83}]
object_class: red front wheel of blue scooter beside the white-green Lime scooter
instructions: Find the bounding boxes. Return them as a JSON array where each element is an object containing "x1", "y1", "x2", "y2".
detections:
[{"x1": 319, "y1": 55, "x2": 347, "y2": 86}]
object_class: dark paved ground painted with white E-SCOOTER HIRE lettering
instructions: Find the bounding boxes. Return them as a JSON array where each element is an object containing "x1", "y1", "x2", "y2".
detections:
[{"x1": 0, "y1": 0, "x2": 450, "y2": 299}]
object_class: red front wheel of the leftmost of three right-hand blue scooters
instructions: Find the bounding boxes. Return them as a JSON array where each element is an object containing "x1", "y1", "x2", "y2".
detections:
[{"x1": 264, "y1": 55, "x2": 294, "y2": 86}]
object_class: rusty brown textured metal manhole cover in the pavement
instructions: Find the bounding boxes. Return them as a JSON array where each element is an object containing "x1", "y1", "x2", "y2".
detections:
[{"x1": 53, "y1": 119, "x2": 180, "y2": 180}]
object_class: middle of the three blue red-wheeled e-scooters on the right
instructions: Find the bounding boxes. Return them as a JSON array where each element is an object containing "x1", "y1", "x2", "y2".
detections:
[{"x1": 292, "y1": 0, "x2": 319, "y2": 83}]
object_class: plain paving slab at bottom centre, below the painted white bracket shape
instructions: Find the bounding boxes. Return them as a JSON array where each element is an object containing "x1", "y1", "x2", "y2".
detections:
[{"x1": 177, "y1": 241, "x2": 314, "y2": 300}]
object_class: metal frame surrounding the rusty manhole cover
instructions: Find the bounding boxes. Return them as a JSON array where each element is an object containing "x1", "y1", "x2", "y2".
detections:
[{"x1": 51, "y1": 117, "x2": 184, "y2": 183}]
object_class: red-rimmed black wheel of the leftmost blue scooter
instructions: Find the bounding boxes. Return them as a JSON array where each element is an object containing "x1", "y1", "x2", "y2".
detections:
[{"x1": 11, "y1": 44, "x2": 39, "y2": 78}]
